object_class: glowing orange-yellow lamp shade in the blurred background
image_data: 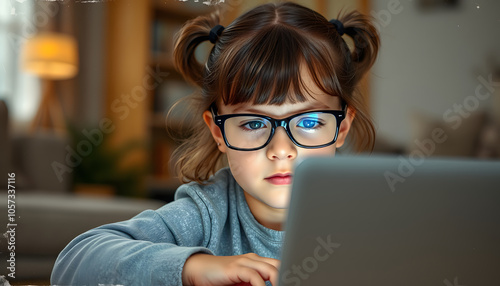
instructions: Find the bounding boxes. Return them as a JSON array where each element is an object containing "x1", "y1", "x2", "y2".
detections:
[{"x1": 21, "y1": 32, "x2": 78, "y2": 79}]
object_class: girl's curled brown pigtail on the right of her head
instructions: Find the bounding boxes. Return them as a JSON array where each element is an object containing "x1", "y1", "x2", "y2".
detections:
[{"x1": 339, "y1": 11, "x2": 380, "y2": 83}]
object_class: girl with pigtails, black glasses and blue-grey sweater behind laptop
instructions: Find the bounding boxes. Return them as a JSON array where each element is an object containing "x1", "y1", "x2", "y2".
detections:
[{"x1": 52, "y1": 3, "x2": 379, "y2": 285}]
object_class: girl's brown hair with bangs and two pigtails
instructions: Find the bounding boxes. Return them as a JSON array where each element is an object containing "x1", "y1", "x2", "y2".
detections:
[{"x1": 173, "y1": 2, "x2": 380, "y2": 182}]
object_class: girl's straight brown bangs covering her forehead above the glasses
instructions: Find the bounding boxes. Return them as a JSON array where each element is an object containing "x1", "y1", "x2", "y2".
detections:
[{"x1": 218, "y1": 24, "x2": 342, "y2": 105}]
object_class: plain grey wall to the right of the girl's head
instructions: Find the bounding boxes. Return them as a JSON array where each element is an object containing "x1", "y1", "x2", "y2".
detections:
[{"x1": 371, "y1": 0, "x2": 500, "y2": 146}]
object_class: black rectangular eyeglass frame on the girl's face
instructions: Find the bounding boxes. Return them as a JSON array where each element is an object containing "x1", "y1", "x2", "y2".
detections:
[{"x1": 210, "y1": 101, "x2": 347, "y2": 151}]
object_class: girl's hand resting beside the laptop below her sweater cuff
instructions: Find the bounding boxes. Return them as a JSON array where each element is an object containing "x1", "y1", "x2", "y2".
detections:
[{"x1": 182, "y1": 253, "x2": 279, "y2": 286}]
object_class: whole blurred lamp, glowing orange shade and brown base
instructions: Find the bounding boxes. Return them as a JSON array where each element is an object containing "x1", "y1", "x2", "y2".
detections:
[{"x1": 21, "y1": 32, "x2": 78, "y2": 131}]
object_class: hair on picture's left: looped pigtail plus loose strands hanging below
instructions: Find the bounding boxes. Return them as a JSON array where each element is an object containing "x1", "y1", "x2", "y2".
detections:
[{"x1": 172, "y1": 11, "x2": 227, "y2": 184}]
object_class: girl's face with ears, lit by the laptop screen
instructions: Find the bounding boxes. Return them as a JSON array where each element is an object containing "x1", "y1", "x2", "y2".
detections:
[{"x1": 204, "y1": 68, "x2": 352, "y2": 228}]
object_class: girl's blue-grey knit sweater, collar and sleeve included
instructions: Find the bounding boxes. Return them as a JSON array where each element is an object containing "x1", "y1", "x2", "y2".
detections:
[{"x1": 51, "y1": 168, "x2": 284, "y2": 286}]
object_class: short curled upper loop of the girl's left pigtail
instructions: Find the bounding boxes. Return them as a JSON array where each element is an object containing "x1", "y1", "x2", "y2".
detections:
[{"x1": 174, "y1": 13, "x2": 219, "y2": 87}]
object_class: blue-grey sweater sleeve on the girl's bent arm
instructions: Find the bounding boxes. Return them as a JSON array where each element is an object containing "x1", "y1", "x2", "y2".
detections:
[{"x1": 51, "y1": 190, "x2": 213, "y2": 286}]
